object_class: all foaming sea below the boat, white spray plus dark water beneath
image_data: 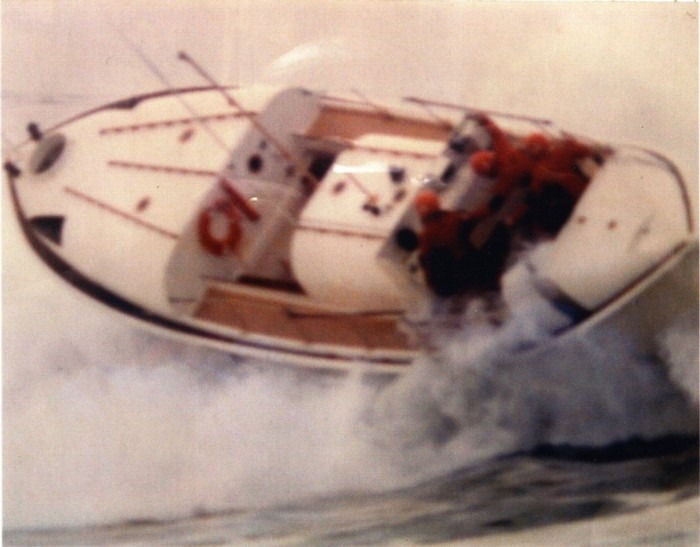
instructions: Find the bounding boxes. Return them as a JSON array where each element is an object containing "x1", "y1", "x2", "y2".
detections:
[{"x1": 3, "y1": 235, "x2": 698, "y2": 544}]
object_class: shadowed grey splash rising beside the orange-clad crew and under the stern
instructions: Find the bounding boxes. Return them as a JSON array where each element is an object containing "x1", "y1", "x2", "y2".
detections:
[{"x1": 365, "y1": 246, "x2": 697, "y2": 473}]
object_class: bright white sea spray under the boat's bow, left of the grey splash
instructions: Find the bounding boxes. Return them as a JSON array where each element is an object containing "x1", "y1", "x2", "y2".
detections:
[{"x1": 3, "y1": 283, "x2": 404, "y2": 529}]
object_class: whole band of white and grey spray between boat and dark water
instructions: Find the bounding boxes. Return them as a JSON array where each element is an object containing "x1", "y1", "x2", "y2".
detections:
[{"x1": 3, "y1": 235, "x2": 698, "y2": 529}]
